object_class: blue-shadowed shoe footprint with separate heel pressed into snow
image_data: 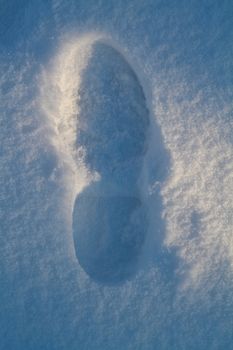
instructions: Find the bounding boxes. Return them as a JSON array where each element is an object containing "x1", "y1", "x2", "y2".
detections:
[{"x1": 73, "y1": 40, "x2": 150, "y2": 284}]
